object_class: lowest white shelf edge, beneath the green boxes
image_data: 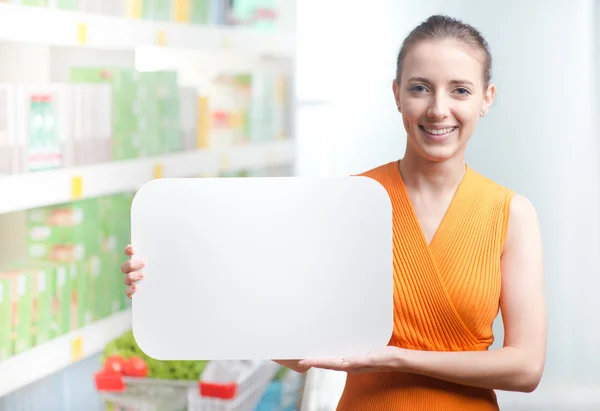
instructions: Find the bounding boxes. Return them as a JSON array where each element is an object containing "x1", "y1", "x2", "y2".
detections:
[{"x1": 0, "y1": 310, "x2": 131, "y2": 397}]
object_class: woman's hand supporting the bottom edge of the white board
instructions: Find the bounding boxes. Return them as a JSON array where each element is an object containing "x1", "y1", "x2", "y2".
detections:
[{"x1": 299, "y1": 346, "x2": 405, "y2": 374}]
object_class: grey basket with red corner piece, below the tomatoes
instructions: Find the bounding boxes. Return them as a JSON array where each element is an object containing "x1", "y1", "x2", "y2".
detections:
[{"x1": 95, "y1": 373, "x2": 198, "y2": 411}]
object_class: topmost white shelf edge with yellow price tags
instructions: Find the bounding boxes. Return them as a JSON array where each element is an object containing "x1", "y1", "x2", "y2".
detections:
[{"x1": 0, "y1": 4, "x2": 295, "y2": 56}]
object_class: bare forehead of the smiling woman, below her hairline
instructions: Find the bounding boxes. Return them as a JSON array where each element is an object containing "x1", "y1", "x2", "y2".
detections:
[{"x1": 402, "y1": 40, "x2": 483, "y2": 84}]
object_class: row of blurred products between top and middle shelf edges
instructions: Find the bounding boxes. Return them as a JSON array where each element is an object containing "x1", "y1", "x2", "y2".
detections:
[{"x1": 0, "y1": 67, "x2": 290, "y2": 175}]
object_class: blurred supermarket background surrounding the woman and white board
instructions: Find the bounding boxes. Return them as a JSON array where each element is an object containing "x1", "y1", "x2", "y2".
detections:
[{"x1": 0, "y1": 0, "x2": 600, "y2": 411}]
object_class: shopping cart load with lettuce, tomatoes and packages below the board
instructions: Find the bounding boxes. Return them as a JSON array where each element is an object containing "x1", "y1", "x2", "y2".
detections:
[{"x1": 94, "y1": 331, "x2": 303, "y2": 411}]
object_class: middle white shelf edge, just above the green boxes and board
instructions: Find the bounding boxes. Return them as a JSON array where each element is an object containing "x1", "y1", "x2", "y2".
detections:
[{"x1": 0, "y1": 140, "x2": 293, "y2": 213}]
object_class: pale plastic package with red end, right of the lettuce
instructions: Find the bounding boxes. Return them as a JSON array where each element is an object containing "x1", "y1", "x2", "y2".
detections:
[{"x1": 188, "y1": 361, "x2": 280, "y2": 411}]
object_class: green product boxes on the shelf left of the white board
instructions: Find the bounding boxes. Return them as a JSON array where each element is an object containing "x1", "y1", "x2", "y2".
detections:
[{"x1": 0, "y1": 194, "x2": 132, "y2": 360}]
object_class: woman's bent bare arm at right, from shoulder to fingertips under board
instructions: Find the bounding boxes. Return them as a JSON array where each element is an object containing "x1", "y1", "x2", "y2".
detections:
[{"x1": 300, "y1": 196, "x2": 546, "y2": 392}]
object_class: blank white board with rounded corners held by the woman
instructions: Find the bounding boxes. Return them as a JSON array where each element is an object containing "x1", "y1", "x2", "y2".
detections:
[{"x1": 131, "y1": 177, "x2": 393, "y2": 360}]
